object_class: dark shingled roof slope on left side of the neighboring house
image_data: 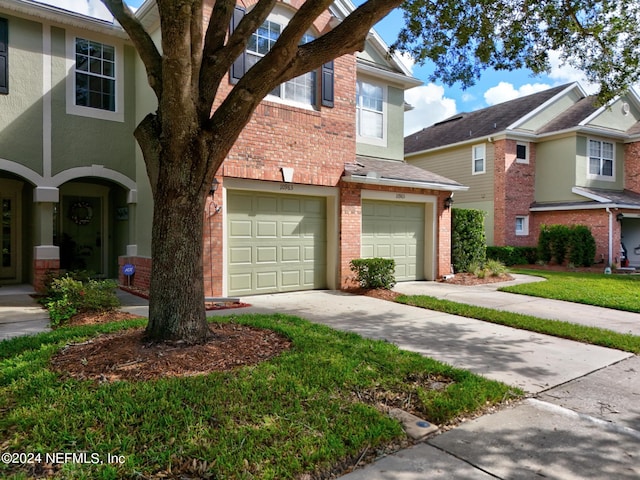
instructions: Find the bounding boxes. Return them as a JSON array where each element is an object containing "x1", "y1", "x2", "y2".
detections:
[{"x1": 404, "y1": 84, "x2": 573, "y2": 154}]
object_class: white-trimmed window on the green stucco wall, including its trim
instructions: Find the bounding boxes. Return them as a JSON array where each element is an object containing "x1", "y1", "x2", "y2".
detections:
[{"x1": 67, "y1": 33, "x2": 124, "y2": 122}]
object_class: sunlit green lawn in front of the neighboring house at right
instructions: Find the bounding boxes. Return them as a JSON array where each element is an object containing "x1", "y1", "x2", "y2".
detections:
[{"x1": 500, "y1": 269, "x2": 640, "y2": 312}]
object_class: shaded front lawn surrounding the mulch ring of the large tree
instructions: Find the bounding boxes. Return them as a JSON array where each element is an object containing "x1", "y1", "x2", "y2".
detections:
[{"x1": 0, "y1": 315, "x2": 522, "y2": 479}]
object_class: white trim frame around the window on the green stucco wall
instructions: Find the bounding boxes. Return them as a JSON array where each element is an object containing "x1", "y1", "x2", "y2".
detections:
[{"x1": 66, "y1": 30, "x2": 124, "y2": 122}]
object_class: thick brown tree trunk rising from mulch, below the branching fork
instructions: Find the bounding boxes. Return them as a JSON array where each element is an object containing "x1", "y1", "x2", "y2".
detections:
[{"x1": 146, "y1": 141, "x2": 210, "y2": 344}]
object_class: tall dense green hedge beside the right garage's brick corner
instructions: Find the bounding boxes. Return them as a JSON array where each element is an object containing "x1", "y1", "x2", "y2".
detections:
[{"x1": 451, "y1": 208, "x2": 487, "y2": 272}]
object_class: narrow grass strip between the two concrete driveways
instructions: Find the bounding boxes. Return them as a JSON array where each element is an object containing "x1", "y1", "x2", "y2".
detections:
[{"x1": 396, "y1": 295, "x2": 640, "y2": 354}]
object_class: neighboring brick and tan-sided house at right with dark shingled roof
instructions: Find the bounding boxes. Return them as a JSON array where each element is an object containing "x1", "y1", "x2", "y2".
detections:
[{"x1": 405, "y1": 83, "x2": 640, "y2": 266}]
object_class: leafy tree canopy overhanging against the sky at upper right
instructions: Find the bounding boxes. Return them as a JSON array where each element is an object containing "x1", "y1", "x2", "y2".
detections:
[{"x1": 394, "y1": 0, "x2": 640, "y2": 101}]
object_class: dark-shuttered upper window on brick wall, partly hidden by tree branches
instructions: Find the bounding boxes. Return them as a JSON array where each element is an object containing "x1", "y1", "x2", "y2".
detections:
[{"x1": 230, "y1": 6, "x2": 333, "y2": 107}]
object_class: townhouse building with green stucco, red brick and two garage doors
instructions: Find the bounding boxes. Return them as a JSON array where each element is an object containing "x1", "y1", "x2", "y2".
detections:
[{"x1": 0, "y1": 0, "x2": 465, "y2": 296}]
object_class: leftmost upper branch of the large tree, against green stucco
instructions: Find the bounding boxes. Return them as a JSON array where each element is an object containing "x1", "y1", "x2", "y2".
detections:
[{"x1": 101, "y1": 0, "x2": 163, "y2": 99}]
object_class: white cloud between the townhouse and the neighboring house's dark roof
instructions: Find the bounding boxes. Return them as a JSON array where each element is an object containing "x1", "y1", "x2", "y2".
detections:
[{"x1": 404, "y1": 83, "x2": 457, "y2": 136}]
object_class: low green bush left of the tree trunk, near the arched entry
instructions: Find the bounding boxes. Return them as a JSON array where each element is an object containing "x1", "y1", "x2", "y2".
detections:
[{"x1": 44, "y1": 275, "x2": 120, "y2": 327}]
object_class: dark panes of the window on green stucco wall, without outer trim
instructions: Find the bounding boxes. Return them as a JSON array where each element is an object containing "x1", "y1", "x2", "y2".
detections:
[{"x1": 76, "y1": 38, "x2": 116, "y2": 112}]
